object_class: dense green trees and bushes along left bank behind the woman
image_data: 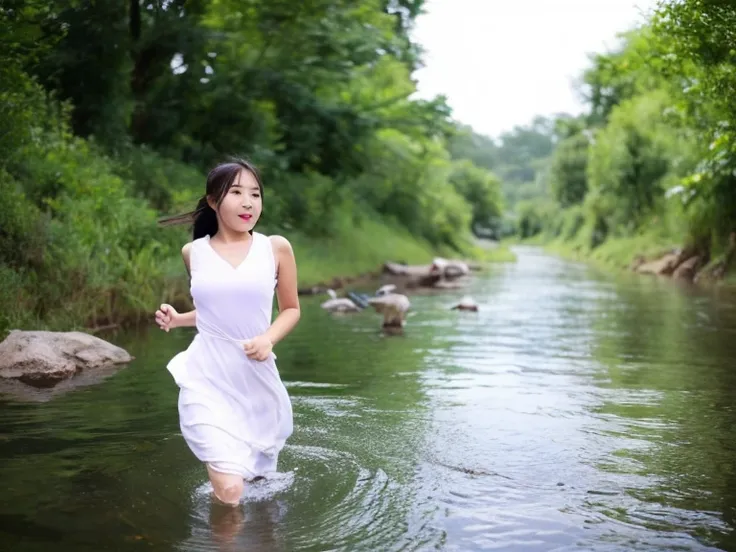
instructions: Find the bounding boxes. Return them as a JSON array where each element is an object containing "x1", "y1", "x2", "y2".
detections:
[{"x1": 0, "y1": 0, "x2": 501, "y2": 329}]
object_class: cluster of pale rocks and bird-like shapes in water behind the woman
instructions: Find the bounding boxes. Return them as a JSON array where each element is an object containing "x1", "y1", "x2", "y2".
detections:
[{"x1": 321, "y1": 258, "x2": 480, "y2": 329}]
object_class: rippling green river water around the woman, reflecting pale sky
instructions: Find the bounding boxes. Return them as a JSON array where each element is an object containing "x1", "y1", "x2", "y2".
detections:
[{"x1": 0, "y1": 249, "x2": 736, "y2": 552}]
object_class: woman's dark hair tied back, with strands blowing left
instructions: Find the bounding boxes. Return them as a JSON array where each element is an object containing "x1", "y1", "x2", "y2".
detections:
[{"x1": 159, "y1": 159, "x2": 263, "y2": 240}]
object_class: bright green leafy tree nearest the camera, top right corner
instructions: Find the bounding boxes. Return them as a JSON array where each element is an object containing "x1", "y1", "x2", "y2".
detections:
[{"x1": 652, "y1": 0, "x2": 736, "y2": 249}]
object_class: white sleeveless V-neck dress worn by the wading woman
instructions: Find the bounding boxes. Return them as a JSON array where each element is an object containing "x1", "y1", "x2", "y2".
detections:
[{"x1": 167, "y1": 232, "x2": 293, "y2": 480}]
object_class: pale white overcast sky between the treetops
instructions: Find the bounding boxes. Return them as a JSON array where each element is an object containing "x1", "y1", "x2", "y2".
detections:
[{"x1": 413, "y1": 0, "x2": 656, "y2": 136}]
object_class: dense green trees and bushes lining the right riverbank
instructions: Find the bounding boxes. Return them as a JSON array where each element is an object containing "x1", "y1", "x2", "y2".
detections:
[{"x1": 506, "y1": 0, "x2": 736, "y2": 274}]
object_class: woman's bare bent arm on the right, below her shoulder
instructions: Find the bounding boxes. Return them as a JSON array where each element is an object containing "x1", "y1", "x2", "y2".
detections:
[{"x1": 265, "y1": 236, "x2": 301, "y2": 345}]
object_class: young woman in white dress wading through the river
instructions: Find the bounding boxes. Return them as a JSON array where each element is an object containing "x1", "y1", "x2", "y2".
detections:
[{"x1": 156, "y1": 160, "x2": 300, "y2": 505}]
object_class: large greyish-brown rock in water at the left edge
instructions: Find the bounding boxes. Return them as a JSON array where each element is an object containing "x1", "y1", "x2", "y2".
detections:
[{"x1": 0, "y1": 330, "x2": 133, "y2": 388}]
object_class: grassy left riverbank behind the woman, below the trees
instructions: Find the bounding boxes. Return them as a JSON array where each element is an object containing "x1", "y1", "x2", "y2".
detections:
[{"x1": 0, "y1": 204, "x2": 514, "y2": 339}]
